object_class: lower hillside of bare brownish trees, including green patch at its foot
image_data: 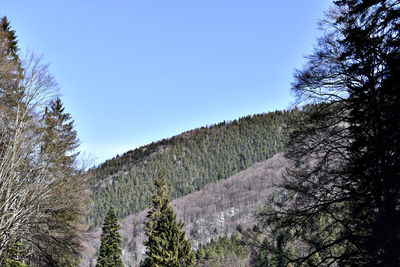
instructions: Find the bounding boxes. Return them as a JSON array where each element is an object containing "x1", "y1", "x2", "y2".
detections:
[{"x1": 80, "y1": 153, "x2": 288, "y2": 267}]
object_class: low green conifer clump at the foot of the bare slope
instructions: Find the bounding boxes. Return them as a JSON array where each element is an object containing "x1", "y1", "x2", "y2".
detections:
[{"x1": 196, "y1": 235, "x2": 247, "y2": 267}]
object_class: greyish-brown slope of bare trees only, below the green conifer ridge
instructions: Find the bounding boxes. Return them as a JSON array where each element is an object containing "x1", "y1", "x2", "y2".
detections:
[{"x1": 81, "y1": 154, "x2": 287, "y2": 266}]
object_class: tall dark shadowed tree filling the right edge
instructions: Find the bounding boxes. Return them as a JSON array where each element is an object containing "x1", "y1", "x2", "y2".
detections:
[{"x1": 247, "y1": 0, "x2": 400, "y2": 266}]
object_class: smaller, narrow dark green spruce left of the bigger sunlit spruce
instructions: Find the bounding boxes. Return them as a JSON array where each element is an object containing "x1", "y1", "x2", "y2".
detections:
[{"x1": 96, "y1": 207, "x2": 123, "y2": 267}]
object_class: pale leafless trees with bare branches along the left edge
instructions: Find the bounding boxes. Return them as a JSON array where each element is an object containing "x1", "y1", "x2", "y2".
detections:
[{"x1": 0, "y1": 25, "x2": 85, "y2": 266}]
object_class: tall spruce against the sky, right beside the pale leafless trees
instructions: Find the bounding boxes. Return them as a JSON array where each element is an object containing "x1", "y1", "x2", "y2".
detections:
[{"x1": 31, "y1": 98, "x2": 86, "y2": 266}]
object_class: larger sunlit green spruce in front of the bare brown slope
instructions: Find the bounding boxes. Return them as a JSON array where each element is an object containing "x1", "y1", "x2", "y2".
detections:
[{"x1": 142, "y1": 174, "x2": 195, "y2": 267}]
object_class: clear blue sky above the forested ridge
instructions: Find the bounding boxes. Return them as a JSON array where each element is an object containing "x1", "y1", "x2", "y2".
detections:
[{"x1": 0, "y1": 0, "x2": 332, "y2": 163}]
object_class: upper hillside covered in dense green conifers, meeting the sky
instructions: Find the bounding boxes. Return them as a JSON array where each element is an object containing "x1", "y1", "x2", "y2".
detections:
[{"x1": 87, "y1": 111, "x2": 294, "y2": 225}]
